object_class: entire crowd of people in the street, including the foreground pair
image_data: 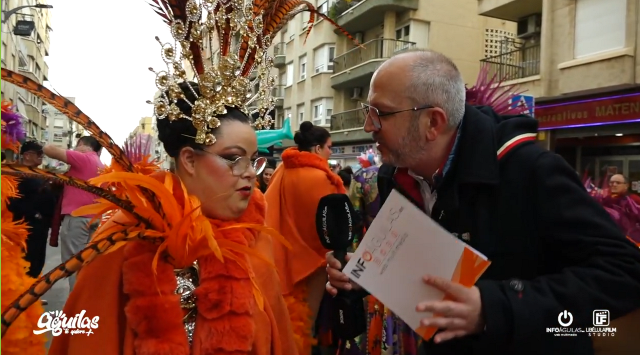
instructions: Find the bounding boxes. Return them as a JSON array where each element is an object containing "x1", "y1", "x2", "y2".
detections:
[{"x1": 2, "y1": 1, "x2": 640, "y2": 355}]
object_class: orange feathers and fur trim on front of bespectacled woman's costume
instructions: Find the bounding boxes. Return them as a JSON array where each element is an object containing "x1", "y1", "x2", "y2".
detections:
[{"x1": 75, "y1": 172, "x2": 289, "y2": 355}]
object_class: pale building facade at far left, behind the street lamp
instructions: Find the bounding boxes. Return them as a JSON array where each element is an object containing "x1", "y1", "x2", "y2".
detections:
[{"x1": 2, "y1": 0, "x2": 51, "y2": 146}]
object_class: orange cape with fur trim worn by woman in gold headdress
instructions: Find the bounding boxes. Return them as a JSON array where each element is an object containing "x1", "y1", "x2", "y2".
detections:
[{"x1": 49, "y1": 190, "x2": 297, "y2": 355}]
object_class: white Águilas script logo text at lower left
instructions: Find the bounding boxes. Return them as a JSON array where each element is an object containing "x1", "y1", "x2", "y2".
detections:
[{"x1": 33, "y1": 310, "x2": 100, "y2": 336}]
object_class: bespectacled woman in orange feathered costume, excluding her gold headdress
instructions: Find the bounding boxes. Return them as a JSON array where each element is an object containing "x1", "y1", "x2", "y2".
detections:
[{"x1": 3, "y1": 83, "x2": 297, "y2": 355}]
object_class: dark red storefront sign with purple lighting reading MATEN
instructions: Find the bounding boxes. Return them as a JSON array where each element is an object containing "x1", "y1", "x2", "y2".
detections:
[{"x1": 536, "y1": 93, "x2": 640, "y2": 130}]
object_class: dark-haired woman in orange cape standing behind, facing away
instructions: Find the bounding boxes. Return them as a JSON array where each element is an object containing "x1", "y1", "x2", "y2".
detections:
[{"x1": 266, "y1": 122, "x2": 345, "y2": 355}]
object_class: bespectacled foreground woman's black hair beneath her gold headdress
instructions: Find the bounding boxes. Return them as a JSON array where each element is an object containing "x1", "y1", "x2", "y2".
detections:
[{"x1": 157, "y1": 82, "x2": 251, "y2": 158}]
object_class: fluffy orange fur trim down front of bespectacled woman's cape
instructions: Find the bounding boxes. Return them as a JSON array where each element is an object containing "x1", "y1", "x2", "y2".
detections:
[{"x1": 123, "y1": 190, "x2": 266, "y2": 355}]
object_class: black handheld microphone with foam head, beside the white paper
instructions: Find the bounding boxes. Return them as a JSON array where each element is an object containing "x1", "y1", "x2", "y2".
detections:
[{"x1": 316, "y1": 194, "x2": 367, "y2": 340}]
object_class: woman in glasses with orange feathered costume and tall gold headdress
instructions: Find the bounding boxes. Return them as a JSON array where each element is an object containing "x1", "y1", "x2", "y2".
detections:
[{"x1": 2, "y1": 0, "x2": 360, "y2": 355}]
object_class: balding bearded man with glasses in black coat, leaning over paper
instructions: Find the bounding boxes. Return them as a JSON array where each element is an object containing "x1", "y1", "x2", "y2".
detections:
[{"x1": 327, "y1": 50, "x2": 640, "y2": 355}]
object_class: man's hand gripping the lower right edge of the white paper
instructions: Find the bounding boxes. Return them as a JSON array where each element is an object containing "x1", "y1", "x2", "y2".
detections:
[{"x1": 416, "y1": 275, "x2": 484, "y2": 343}]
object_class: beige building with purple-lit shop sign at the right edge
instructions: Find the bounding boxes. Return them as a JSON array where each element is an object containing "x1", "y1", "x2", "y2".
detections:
[{"x1": 478, "y1": 0, "x2": 640, "y2": 197}]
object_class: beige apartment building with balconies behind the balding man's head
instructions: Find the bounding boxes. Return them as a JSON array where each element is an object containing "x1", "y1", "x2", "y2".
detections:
[{"x1": 273, "y1": 0, "x2": 515, "y2": 166}]
